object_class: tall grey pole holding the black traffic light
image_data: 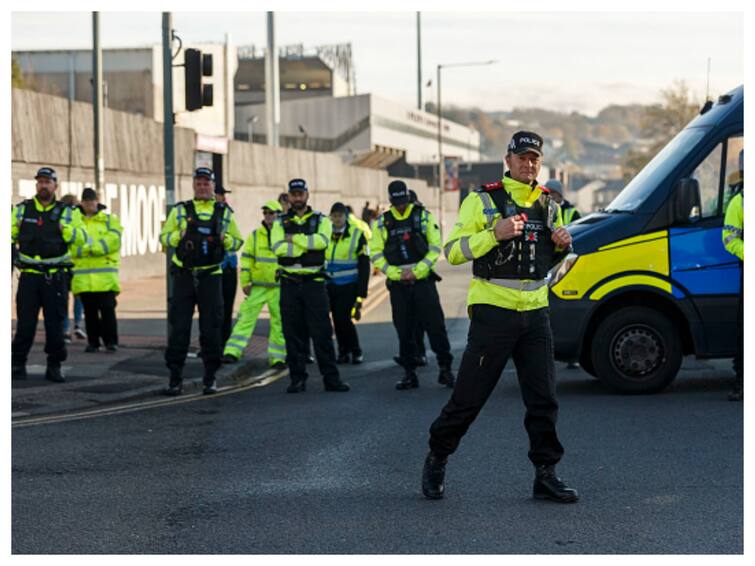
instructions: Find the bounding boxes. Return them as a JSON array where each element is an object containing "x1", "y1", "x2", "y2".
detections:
[{"x1": 163, "y1": 12, "x2": 176, "y2": 335}]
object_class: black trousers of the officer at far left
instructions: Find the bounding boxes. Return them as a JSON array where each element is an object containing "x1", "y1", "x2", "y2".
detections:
[{"x1": 11, "y1": 271, "x2": 68, "y2": 367}]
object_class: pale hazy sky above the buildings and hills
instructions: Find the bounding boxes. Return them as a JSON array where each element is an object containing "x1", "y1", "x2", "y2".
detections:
[{"x1": 11, "y1": 12, "x2": 744, "y2": 113}]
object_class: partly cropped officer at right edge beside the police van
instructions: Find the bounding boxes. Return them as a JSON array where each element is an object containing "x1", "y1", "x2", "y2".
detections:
[{"x1": 721, "y1": 150, "x2": 745, "y2": 401}]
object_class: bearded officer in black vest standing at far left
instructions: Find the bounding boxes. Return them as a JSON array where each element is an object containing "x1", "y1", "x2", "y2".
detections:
[{"x1": 11, "y1": 167, "x2": 87, "y2": 382}]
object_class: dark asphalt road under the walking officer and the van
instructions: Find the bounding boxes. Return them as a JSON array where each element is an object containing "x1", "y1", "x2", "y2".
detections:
[{"x1": 12, "y1": 265, "x2": 743, "y2": 554}]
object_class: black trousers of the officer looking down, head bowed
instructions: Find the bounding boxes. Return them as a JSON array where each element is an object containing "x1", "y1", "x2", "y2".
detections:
[{"x1": 388, "y1": 278, "x2": 453, "y2": 370}]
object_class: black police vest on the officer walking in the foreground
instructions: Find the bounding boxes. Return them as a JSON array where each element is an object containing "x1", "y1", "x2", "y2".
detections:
[{"x1": 472, "y1": 188, "x2": 556, "y2": 279}]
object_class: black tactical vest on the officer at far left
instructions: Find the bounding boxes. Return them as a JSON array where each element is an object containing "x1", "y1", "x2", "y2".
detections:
[{"x1": 18, "y1": 199, "x2": 68, "y2": 259}]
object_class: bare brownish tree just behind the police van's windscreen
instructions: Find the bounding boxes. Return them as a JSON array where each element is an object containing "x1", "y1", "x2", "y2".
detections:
[{"x1": 621, "y1": 80, "x2": 700, "y2": 180}]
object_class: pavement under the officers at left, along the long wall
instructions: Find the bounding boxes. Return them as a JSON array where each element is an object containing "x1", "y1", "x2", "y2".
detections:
[{"x1": 11, "y1": 276, "x2": 383, "y2": 423}]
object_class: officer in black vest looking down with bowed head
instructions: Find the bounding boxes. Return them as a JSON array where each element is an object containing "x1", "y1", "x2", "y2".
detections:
[{"x1": 370, "y1": 180, "x2": 454, "y2": 390}]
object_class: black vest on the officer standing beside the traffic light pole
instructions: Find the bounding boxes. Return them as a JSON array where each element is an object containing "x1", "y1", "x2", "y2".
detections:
[{"x1": 176, "y1": 200, "x2": 226, "y2": 268}]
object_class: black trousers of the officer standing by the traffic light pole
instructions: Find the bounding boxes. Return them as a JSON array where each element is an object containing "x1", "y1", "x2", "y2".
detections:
[{"x1": 165, "y1": 267, "x2": 223, "y2": 382}]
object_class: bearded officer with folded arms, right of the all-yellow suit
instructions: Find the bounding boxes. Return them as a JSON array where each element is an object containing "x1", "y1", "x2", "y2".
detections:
[{"x1": 270, "y1": 179, "x2": 349, "y2": 393}]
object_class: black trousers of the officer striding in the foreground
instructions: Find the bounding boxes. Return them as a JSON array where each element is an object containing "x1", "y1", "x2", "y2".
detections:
[{"x1": 430, "y1": 305, "x2": 564, "y2": 465}]
